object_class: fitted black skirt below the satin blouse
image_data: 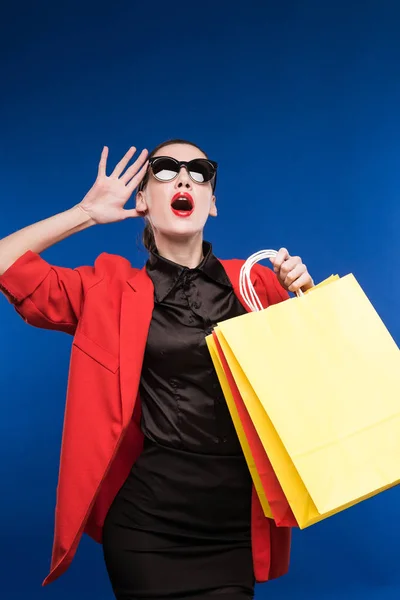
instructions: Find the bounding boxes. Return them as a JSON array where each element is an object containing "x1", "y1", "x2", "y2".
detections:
[{"x1": 103, "y1": 440, "x2": 254, "y2": 600}]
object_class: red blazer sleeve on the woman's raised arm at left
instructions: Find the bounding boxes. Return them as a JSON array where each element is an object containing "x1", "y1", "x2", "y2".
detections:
[{"x1": 0, "y1": 250, "x2": 102, "y2": 335}]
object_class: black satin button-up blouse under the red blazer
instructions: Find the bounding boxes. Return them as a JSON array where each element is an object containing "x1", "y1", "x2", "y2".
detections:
[{"x1": 140, "y1": 242, "x2": 246, "y2": 455}]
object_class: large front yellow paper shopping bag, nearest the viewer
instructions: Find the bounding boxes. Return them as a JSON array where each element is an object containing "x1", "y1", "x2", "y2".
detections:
[{"x1": 215, "y1": 251, "x2": 400, "y2": 528}]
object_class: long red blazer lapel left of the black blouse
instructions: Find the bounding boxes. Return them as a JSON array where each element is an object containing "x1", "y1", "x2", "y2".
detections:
[{"x1": 120, "y1": 268, "x2": 154, "y2": 428}]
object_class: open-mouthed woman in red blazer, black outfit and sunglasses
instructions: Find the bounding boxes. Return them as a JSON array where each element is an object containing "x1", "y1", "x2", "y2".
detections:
[{"x1": 0, "y1": 140, "x2": 313, "y2": 600}]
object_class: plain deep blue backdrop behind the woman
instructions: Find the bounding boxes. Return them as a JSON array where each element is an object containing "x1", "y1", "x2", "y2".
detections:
[{"x1": 0, "y1": 0, "x2": 400, "y2": 600}]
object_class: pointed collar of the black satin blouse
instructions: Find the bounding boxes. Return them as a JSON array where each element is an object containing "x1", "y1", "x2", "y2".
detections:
[{"x1": 146, "y1": 242, "x2": 232, "y2": 302}]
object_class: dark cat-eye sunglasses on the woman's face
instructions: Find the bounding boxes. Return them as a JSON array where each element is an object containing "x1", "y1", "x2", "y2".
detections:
[{"x1": 139, "y1": 156, "x2": 218, "y2": 190}]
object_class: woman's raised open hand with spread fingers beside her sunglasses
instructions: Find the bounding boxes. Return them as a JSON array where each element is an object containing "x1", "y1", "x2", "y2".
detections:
[{"x1": 78, "y1": 146, "x2": 148, "y2": 224}]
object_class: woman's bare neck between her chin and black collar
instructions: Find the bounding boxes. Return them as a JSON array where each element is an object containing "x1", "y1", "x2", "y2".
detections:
[{"x1": 152, "y1": 233, "x2": 203, "y2": 269}]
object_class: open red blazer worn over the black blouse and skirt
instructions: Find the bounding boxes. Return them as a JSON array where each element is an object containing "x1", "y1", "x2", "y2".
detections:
[{"x1": 0, "y1": 251, "x2": 291, "y2": 585}]
